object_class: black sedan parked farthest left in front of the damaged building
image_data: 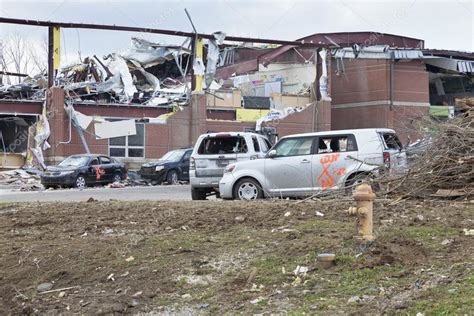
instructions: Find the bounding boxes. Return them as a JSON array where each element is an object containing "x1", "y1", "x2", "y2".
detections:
[{"x1": 41, "y1": 155, "x2": 127, "y2": 188}]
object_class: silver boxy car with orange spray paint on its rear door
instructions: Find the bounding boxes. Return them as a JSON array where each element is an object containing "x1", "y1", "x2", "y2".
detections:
[{"x1": 219, "y1": 129, "x2": 406, "y2": 200}]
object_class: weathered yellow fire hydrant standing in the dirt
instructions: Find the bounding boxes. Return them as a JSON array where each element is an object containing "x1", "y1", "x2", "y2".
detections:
[{"x1": 346, "y1": 183, "x2": 375, "y2": 241}]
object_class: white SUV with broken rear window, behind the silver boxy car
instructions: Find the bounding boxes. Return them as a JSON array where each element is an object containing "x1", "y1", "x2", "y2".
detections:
[{"x1": 189, "y1": 132, "x2": 271, "y2": 200}]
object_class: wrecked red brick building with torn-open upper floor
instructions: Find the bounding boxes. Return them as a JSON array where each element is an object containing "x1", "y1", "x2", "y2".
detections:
[{"x1": 0, "y1": 17, "x2": 474, "y2": 168}]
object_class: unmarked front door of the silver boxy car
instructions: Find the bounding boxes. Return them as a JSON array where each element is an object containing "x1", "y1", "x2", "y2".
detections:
[{"x1": 264, "y1": 136, "x2": 315, "y2": 196}]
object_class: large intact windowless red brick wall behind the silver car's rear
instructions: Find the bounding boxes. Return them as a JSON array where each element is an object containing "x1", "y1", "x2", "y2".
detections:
[{"x1": 331, "y1": 59, "x2": 429, "y2": 139}]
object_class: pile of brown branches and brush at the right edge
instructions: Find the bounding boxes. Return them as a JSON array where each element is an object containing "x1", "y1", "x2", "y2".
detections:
[{"x1": 375, "y1": 108, "x2": 474, "y2": 198}]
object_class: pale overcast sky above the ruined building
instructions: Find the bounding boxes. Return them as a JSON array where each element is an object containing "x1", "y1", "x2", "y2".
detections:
[{"x1": 0, "y1": 0, "x2": 474, "y2": 68}]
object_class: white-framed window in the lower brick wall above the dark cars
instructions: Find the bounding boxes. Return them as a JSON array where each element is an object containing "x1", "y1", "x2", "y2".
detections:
[{"x1": 109, "y1": 123, "x2": 145, "y2": 158}]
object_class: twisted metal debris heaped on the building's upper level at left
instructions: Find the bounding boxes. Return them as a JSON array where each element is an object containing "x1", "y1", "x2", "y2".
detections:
[{"x1": 0, "y1": 38, "x2": 190, "y2": 106}]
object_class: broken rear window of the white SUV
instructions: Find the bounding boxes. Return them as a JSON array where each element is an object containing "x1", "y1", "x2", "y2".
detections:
[{"x1": 198, "y1": 136, "x2": 248, "y2": 155}]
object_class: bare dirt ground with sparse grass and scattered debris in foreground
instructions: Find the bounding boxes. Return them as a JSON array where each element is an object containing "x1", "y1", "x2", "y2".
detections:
[{"x1": 0, "y1": 200, "x2": 474, "y2": 315}]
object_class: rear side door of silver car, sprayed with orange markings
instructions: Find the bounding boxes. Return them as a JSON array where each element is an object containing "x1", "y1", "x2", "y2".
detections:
[{"x1": 312, "y1": 134, "x2": 360, "y2": 192}]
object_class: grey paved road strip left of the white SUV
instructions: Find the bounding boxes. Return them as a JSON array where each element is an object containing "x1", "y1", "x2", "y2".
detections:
[{"x1": 0, "y1": 185, "x2": 191, "y2": 202}]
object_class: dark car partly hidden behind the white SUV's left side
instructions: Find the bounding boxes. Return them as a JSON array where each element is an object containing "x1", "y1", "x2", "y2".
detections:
[{"x1": 139, "y1": 148, "x2": 193, "y2": 184}]
